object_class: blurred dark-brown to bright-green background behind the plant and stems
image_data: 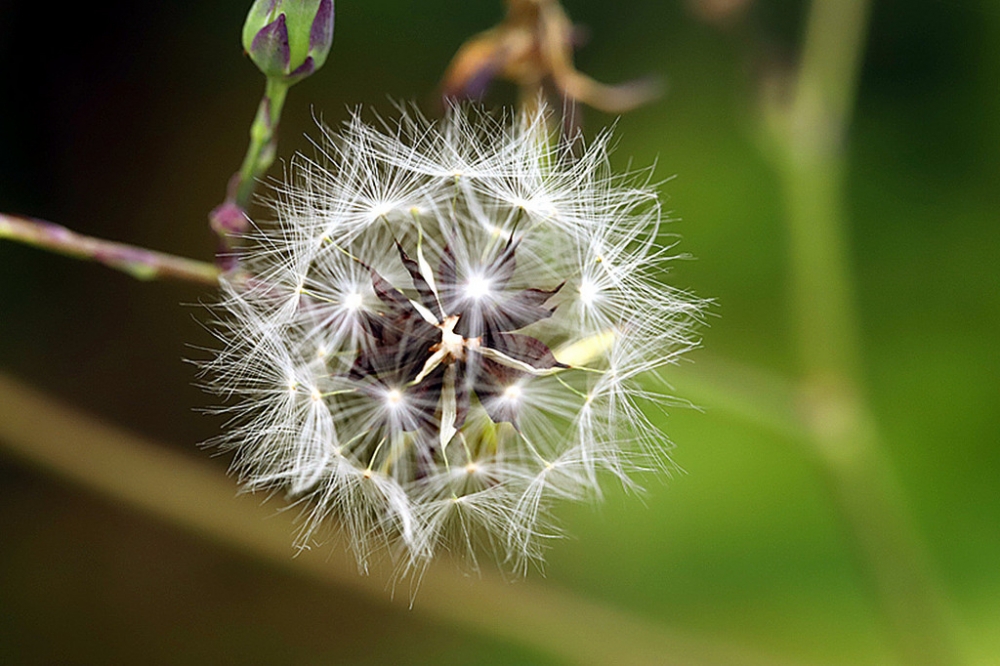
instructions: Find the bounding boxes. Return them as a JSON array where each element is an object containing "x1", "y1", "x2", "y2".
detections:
[{"x1": 0, "y1": 0, "x2": 1000, "y2": 665}]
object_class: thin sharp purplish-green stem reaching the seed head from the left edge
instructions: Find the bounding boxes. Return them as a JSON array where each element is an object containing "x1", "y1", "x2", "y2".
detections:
[{"x1": 0, "y1": 213, "x2": 220, "y2": 286}]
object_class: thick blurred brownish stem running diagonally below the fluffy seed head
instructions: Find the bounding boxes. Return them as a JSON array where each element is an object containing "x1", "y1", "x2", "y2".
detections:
[{"x1": 0, "y1": 374, "x2": 790, "y2": 666}]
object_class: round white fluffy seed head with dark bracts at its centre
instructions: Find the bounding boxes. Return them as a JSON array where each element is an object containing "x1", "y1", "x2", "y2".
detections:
[{"x1": 205, "y1": 108, "x2": 701, "y2": 571}]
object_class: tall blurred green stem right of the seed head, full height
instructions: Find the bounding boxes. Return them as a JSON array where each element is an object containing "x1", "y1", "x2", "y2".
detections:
[{"x1": 767, "y1": 0, "x2": 959, "y2": 666}]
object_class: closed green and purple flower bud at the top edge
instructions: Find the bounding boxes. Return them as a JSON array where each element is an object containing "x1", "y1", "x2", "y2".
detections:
[{"x1": 243, "y1": 0, "x2": 333, "y2": 85}]
